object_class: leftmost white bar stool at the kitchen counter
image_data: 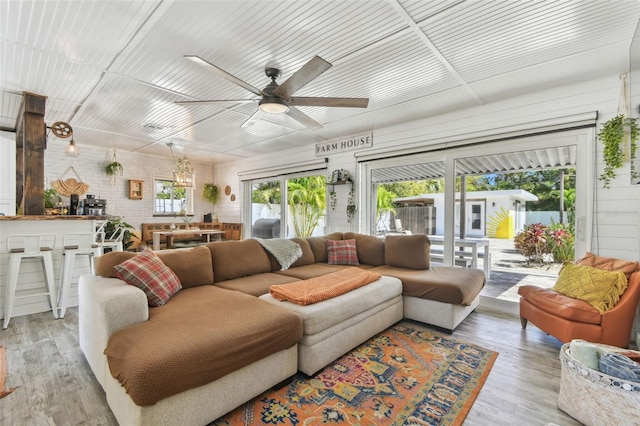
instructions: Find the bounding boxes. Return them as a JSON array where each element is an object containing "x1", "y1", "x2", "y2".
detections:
[{"x1": 2, "y1": 234, "x2": 58, "y2": 329}]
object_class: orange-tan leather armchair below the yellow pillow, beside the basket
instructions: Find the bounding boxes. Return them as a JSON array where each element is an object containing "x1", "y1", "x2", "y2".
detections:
[{"x1": 518, "y1": 271, "x2": 640, "y2": 348}]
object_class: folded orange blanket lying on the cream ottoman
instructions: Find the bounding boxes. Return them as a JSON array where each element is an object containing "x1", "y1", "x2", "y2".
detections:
[{"x1": 269, "y1": 268, "x2": 381, "y2": 305}]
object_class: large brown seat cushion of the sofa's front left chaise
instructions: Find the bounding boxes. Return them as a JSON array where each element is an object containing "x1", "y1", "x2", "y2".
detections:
[{"x1": 105, "y1": 285, "x2": 302, "y2": 406}]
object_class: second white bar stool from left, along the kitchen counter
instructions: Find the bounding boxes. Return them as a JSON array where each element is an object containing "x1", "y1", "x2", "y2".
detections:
[{"x1": 58, "y1": 233, "x2": 101, "y2": 318}]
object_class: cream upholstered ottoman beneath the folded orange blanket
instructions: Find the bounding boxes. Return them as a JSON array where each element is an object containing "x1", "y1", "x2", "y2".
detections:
[{"x1": 260, "y1": 275, "x2": 403, "y2": 376}]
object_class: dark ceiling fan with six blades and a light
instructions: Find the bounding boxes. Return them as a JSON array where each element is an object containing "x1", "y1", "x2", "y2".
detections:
[{"x1": 176, "y1": 55, "x2": 369, "y2": 129}]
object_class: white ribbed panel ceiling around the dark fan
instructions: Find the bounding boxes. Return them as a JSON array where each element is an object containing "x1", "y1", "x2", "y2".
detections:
[{"x1": 0, "y1": 0, "x2": 640, "y2": 162}]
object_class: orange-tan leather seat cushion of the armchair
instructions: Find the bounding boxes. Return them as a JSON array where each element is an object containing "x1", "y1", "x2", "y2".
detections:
[{"x1": 518, "y1": 285, "x2": 602, "y2": 324}]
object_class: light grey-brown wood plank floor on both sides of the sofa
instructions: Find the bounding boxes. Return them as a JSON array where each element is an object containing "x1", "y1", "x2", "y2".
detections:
[{"x1": 0, "y1": 308, "x2": 580, "y2": 426}]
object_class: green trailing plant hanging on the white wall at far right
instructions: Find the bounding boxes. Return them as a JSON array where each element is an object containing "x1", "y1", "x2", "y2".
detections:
[{"x1": 598, "y1": 114, "x2": 639, "y2": 188}]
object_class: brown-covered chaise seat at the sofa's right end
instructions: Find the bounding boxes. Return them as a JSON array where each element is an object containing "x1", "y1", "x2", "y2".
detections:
[{"x1": 371, "y1": 265, "x2": 486, "y2": 306}]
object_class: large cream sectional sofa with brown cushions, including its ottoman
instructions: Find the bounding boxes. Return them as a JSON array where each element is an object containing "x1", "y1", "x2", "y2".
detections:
[{"x1": 79, "y1": 233, "x2": 485, "y2": 425}]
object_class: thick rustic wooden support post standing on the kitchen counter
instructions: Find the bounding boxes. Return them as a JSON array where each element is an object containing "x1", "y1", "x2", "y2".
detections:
[{"x1": 16, "y1": 92, "x2": 47, "y2": 215}]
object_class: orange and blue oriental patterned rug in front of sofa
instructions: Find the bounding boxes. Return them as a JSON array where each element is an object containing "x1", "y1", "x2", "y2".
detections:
[{"x1": 211, "y1": 323, "x2": 498, "y2": 426}]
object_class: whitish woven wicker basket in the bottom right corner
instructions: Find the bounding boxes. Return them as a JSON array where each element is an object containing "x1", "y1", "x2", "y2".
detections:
[{"x1": 558, "y1": 343, "x2": 640, "y2": 426}]
